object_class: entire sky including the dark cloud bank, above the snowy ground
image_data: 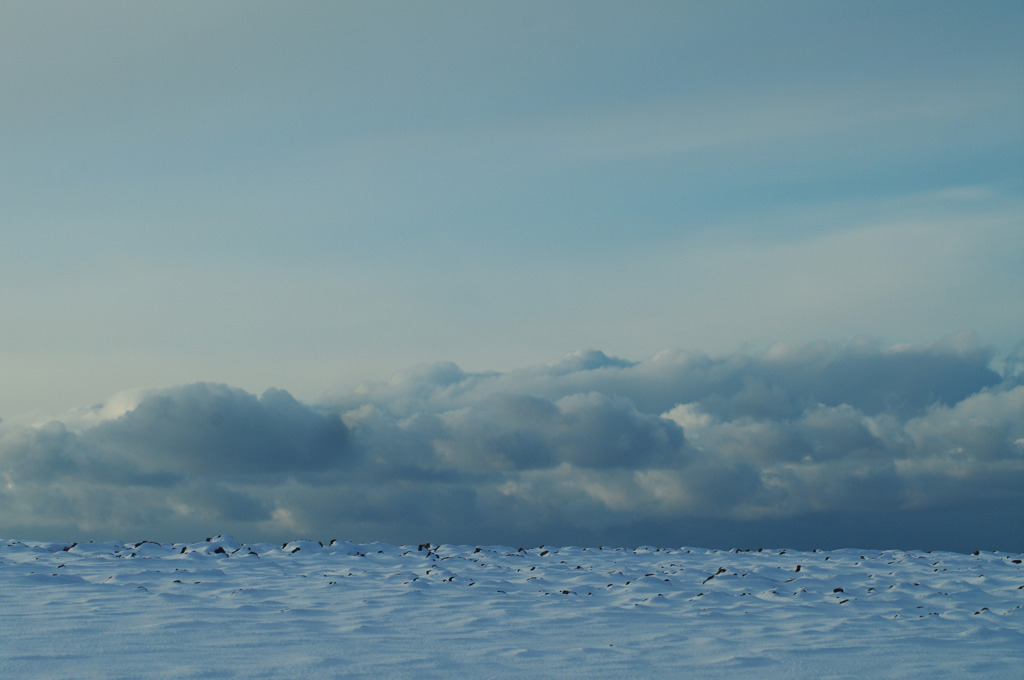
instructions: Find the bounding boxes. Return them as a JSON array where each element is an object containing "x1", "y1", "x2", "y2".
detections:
[{"x1": 0, "y1": 1, "x2": 1024, "y2": 550}]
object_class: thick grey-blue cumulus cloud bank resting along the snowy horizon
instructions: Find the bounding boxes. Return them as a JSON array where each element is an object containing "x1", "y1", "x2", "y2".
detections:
[{"x1": 0, "y1": 338, "x2": 1024, "y2": 551}]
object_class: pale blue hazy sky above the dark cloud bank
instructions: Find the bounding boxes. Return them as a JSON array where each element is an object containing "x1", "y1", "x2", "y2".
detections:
[{"x1": 0, "y1": 2, "x2": 1024, "y2": 548}]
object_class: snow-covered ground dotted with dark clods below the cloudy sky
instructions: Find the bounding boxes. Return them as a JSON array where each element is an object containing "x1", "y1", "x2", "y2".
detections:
[{"x1": 0, "y1": 537, "x2": 1024, "y2": 680}]
